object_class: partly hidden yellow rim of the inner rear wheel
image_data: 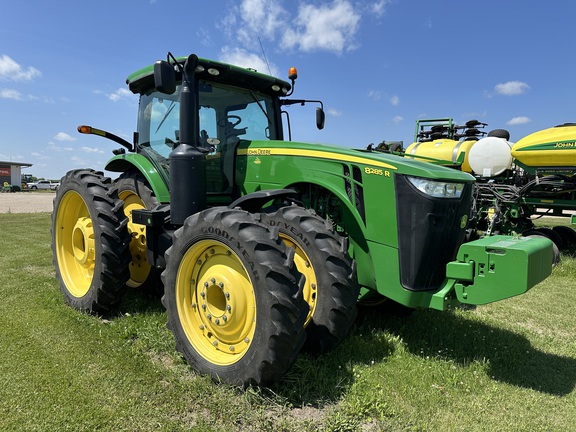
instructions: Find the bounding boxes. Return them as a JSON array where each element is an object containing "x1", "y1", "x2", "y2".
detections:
[{"x1": 119, "y1": 191, "x2": 151, "y2": 288}]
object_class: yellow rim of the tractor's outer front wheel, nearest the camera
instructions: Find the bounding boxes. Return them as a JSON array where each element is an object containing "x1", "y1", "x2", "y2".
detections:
[{"x1": 176, "y1": 240, "x2": 256, "y2": 366}]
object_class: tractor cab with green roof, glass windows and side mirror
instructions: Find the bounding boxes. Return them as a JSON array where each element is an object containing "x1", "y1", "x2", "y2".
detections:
[{"x1": 102, "y1": 54, "x2": 325, "y2": 205}]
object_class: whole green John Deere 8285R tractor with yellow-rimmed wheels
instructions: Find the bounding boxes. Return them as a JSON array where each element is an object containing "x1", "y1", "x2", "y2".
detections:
[{"x1": 52, "y1": 54, "x2": 552, "y2": 386}]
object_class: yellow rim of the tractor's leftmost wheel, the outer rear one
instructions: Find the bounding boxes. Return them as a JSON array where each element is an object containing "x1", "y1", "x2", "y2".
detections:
[{"x1": 54, "y1": 191, "x2": 96, "y2": 298}]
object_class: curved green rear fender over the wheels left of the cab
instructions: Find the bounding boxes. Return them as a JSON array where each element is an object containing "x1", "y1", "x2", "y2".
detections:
[{"x1": 105, "y1": 153, "x2": 170, "y2": 203}]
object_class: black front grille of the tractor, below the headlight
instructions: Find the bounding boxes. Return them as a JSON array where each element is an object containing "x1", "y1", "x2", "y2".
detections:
[{"x1": 395, "y1": 175, "x2": 472, "y2": 291}]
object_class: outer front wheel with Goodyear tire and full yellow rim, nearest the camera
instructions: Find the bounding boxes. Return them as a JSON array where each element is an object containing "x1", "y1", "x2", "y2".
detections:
[{"x1": 162, "y1": 207, "x2": 308, "y2": 387}]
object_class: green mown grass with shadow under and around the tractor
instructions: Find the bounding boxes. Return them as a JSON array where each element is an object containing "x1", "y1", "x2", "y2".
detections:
[{"x1": 0, "y1": 213, "x2": 576, "y2": 432}]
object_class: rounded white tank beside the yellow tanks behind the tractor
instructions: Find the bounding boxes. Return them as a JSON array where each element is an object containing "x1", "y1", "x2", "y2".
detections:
[{"x1": 468, "y1": 137, "x2": 512, "y2": 177}]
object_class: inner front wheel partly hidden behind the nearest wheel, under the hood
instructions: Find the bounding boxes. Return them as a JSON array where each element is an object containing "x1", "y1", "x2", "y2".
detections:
[{"x1": 261, "y1": 205, "x2": 359, "y2": 354}]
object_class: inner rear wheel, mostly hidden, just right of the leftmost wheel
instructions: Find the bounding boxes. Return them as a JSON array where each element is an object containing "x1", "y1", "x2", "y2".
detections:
[{"x1": 116, "y1": 171, "x2": 162, "y2": 295}]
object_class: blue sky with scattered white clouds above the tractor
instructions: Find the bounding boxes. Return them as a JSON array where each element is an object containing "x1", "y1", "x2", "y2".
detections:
[{"x1": 0, "y1": 0, "x2": 576, "y2": 179}]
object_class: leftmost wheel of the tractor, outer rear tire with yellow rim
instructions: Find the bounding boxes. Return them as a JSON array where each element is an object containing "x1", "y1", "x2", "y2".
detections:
[{"x1": 51, "y1": 169, "x2": 130, "y2": 314}]
